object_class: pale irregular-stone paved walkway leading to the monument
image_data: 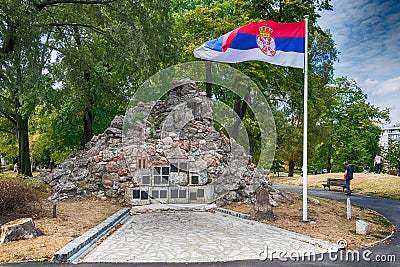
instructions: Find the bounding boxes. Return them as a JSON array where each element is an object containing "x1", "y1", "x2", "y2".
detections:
[{"x1": 81, "y1": 211, "x2": 336, "y2": 262}]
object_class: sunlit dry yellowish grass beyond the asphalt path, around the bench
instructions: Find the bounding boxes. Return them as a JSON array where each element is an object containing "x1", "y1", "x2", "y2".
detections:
[{"x1": 271, "y1": 173, "x2": 400, "y2": 199}]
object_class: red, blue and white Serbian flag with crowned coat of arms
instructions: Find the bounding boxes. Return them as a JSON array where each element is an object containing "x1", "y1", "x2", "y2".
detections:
[{"x1": 194, "y1": 20, "x2": 305, "y2": 68}]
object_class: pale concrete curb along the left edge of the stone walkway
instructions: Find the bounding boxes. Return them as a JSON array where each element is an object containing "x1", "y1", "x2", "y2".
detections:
[{"x1": 51, "y1": 208, "x2": 130, "y2": 263}]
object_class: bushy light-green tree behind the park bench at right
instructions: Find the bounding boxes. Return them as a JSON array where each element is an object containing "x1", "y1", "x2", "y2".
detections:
[{"x1": 314, "y1": 77, "x2": 389, "y2": 173}]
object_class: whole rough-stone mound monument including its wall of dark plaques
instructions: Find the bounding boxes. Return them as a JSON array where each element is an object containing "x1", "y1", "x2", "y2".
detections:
[{"x1": 45, "y1": 79, "x2": 268, "y2": 205}]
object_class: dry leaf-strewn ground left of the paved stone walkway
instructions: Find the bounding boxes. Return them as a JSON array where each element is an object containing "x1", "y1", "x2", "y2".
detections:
[{"x1": 0, "y1": 199, "x2": 122, "y2": 263}]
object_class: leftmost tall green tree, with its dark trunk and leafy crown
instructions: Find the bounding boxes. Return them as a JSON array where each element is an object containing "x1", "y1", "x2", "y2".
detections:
[{"x1": 0, "y1": 0, "x2": 49, "y2": 178}]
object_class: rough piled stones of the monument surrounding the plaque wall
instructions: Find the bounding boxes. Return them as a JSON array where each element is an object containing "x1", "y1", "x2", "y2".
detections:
[{"x1": 44, "y1": 78, "x2": 282, "y2": 204}]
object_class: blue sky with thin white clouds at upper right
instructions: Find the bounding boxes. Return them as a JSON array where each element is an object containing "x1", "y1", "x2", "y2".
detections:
[{"x1": 318, "y1": 0, "x2": 400, "y2": 124}]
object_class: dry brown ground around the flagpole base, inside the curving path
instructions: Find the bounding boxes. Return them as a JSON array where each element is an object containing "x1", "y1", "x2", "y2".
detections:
[{"x1": 224, "y1": 193, "x2": 394, "y2": 249}]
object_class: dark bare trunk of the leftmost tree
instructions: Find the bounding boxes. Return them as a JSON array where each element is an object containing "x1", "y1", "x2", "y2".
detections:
[{"x1": 16, "y1": 113, "x2": 32, "y2": 176}]
